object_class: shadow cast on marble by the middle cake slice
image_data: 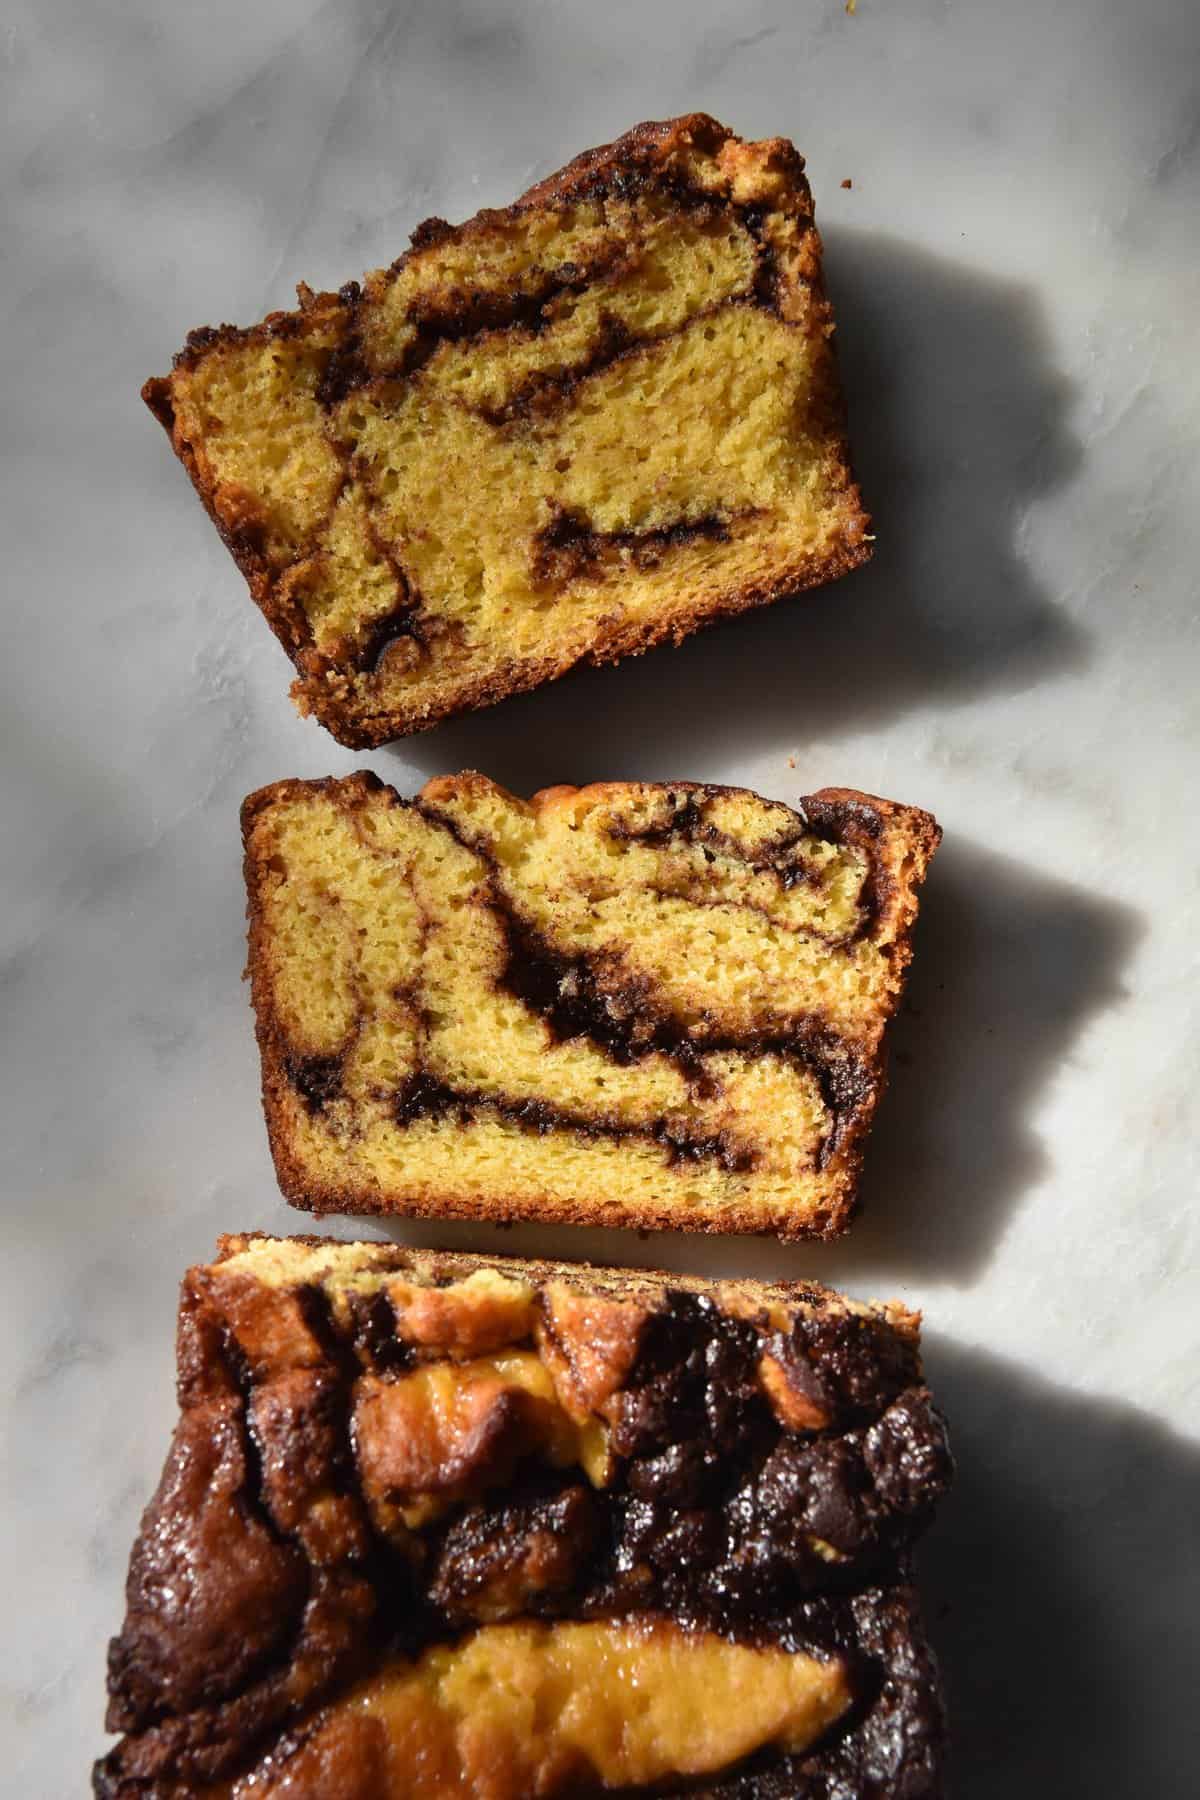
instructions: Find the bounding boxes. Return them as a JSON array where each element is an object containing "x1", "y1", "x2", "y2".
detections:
[{"x1": 367, "y1": 837, "x2": 1144, "y2": 1291}]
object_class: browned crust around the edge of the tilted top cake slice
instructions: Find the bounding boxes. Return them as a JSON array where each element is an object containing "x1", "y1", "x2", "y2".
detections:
[{"x1": 142, "y1": 113, "x2": 873, "y2": 749}]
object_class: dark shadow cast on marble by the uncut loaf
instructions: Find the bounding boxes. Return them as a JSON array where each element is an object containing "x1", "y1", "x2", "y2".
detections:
[{"x1": 921, "y1": 1346, "x2": 1200, "y2": 1800}]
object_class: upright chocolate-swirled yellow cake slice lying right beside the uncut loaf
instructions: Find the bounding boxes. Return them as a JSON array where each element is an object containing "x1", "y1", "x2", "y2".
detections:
[{"x1": 243, "y1": 774, "x2": 939, "y2": 1237}]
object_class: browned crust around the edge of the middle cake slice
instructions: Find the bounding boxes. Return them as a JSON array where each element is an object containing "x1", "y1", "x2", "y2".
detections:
[{"x1": 241, "y1": 770, "x2": 941, "y2": 1242}]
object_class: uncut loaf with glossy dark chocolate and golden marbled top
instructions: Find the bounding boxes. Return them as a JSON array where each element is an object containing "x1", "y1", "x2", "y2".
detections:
[{"x1": 95, "y1": 1237, "x2": 950, "y2": 1800}]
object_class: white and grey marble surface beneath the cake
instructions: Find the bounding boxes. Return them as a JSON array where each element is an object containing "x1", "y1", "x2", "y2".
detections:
[{"x1": 0, "y1": 0, "x2": 1200, "y2": 1800}]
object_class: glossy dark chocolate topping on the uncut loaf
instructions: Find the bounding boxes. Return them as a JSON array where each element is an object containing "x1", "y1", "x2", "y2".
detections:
[{"x1": 95, "y1": 1253, "x2": 952, "y2": 1800}]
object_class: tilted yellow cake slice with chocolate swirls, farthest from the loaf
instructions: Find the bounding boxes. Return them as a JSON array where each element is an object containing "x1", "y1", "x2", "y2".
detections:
[{"x1": 144, "y1": 113, "x2": 871, "y2": 745}]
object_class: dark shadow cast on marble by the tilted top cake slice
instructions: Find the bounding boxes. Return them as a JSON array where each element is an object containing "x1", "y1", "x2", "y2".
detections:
[{"x1": 394, "y1": 230, "x2": 1088, "y2": 792}]
